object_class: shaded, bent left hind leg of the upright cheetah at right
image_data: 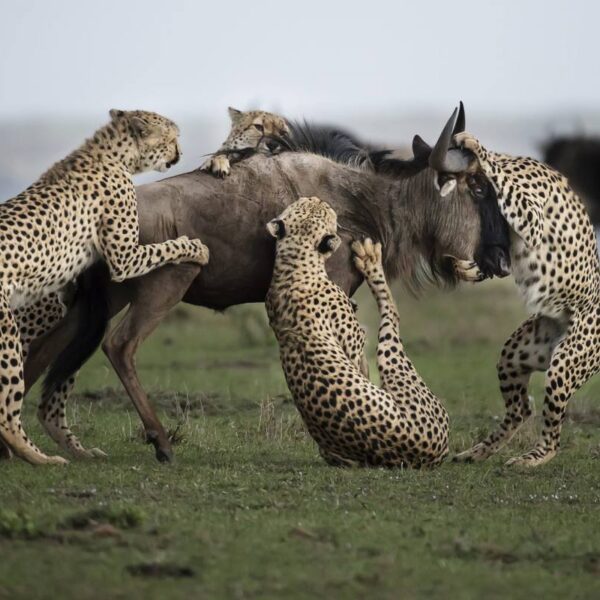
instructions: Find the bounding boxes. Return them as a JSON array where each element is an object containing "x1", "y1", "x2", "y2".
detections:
[{"x1": 454, "y1": 315, "x2": 563, "y2": 462}]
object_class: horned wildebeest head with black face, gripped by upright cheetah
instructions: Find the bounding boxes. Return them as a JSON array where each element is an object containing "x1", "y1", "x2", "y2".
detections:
[{"x1": 370, "y1": 104, "x2": 510, "y2": 284}]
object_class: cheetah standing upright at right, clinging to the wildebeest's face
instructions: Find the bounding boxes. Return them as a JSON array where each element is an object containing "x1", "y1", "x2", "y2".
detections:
[{"x1": 454, "y1": 133, "x2": 600, "y2": 467}]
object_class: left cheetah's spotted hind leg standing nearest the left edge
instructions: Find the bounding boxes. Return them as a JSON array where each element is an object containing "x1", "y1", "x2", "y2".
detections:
[{"x1": 0, "y1": 292, "x2": 67, "y2": 464}]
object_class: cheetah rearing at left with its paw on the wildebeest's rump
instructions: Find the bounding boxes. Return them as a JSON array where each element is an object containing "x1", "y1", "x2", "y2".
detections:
[{"x1": 0, "y1": 110, "x2": 208, "y2": 464}]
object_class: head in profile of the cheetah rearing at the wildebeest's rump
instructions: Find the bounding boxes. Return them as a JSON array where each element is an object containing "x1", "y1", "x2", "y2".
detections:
[{"x1": 110, "y1": 109, "x2": 182, "y2": 173}]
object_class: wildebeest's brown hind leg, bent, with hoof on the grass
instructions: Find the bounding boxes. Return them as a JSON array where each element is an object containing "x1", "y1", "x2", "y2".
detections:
[{"x1": 102, "y1": 264, "x2": 201, "y2": 462}]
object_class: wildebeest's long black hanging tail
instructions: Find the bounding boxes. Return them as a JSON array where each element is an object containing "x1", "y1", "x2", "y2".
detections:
[{"x1": 43, "y1": 261, "x2": 110, "y2": 398}]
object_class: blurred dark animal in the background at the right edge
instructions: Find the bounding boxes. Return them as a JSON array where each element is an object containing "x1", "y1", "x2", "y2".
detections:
[{"x1": 542, "y1": 136, "x2": 600, "y2": 227}]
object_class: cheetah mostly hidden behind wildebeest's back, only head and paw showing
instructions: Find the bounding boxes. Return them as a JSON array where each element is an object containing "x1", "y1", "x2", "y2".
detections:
[{"x1": 200, "y1": 106, "x2": 289, "y2": 177}]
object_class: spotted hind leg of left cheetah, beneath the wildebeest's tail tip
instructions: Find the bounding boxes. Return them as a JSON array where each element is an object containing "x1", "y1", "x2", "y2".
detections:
[{"x1": 38, "y1": 377, "x2": 108, "y2": 459}]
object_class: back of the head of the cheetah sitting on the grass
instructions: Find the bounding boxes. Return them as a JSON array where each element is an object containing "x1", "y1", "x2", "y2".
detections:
[{"x1": 267, "y1": 196, "x2": 341, "y2": 260}]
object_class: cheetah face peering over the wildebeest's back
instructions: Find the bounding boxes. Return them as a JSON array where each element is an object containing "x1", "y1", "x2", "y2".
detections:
[{"x1": 228, "y1": 106, "x2": 290, "y2": 151}]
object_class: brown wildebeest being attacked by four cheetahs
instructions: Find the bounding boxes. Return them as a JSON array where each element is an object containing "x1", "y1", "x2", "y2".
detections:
[{"x1": 19, "y1": 118, "x2": 508, "y2": 460}]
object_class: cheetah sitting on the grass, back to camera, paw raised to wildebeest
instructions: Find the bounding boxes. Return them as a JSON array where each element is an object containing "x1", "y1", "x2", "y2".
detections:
[{"x1": 266, "y1": 197, "x2": 448, "y2": 468}]
